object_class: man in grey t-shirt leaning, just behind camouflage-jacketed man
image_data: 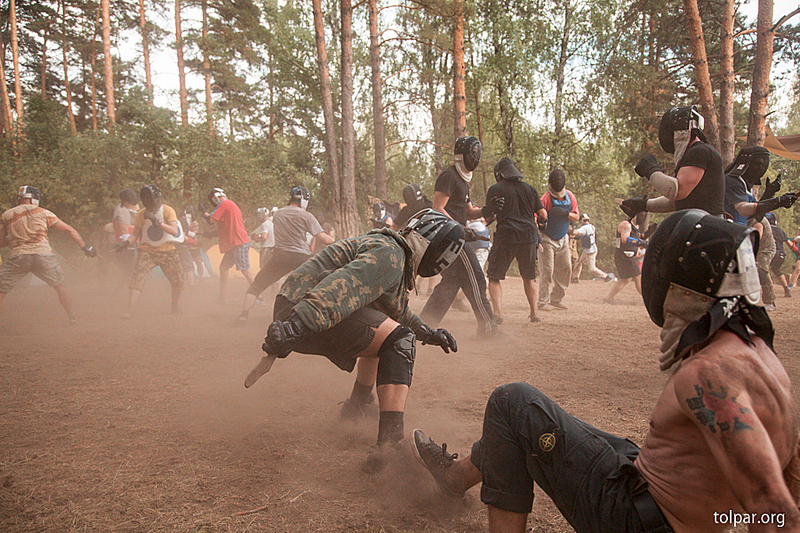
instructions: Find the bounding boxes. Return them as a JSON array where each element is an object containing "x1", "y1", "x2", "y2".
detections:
[{"x1": 236, "y1": 186, "x2": 334, "y2": 325}]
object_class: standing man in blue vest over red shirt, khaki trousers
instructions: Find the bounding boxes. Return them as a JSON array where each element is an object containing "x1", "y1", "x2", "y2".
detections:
[{"x1": 539, "y1": 168, "x2": 580, "y2": 311}]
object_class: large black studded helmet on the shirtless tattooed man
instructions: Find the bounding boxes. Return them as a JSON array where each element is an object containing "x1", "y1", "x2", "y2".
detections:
[{"x1": 642, "y1": 209, "x2": 760, "y2": 327}]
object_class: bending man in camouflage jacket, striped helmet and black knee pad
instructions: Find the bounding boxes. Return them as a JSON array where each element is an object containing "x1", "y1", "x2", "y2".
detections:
[{"x1": 245, "y1": 209, "x2": 464, "y2": 472}]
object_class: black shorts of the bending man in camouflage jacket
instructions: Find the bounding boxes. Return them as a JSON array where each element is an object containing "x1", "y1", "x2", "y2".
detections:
[{"x1": 272, "y1": 294, "x2": 389, "y2": 372}]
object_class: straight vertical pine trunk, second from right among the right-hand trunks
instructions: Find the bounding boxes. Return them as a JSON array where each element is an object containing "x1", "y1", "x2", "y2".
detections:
[{"x1": 719, "y1": 0, "x2": 736, "y2": 167}]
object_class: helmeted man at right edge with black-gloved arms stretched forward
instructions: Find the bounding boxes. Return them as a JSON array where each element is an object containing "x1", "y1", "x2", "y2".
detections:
[{"x1": 725, "y1": 146, "x2": 797, "y2": 311}]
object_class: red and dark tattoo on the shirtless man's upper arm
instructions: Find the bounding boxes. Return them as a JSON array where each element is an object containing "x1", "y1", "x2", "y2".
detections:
[{"x1": 686, "y1": 383, "x2": 753, "y2": 434}]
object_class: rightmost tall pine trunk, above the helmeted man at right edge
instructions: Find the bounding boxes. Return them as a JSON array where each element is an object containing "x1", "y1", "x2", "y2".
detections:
[{"x1": 747, "y1": 0, "x2": 775, "y2": 146}]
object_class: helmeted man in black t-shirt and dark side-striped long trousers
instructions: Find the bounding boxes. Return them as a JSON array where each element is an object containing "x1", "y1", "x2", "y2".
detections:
[{"x1": 420, "y1": 136, "x2": 505, "y2": 336}]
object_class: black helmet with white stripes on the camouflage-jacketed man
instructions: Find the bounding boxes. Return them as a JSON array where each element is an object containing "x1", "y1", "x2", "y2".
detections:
[{"x1": 403, "y1": 208, "x2": 464, "y2": 278}]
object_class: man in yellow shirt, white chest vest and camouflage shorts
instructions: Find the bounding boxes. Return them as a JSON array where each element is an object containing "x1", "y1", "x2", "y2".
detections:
[{"x1": 117, "y1": 185, "x2": 185, "y2": 319}]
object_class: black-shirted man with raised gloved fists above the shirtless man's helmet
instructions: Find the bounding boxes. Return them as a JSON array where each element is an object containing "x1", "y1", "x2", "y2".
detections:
[{"x1": 617, "y1": 105, "x2": 725, "y2": 217}]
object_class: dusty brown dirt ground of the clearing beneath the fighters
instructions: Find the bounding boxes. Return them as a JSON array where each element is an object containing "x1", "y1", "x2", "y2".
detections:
[{"x1": 0, "y1": 266, "x2": 800, "y2": 533}]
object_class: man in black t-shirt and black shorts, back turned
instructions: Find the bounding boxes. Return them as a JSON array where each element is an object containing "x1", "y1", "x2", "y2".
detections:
[{"x1": 486, "y1": 157, "x2": 547, "y2": 324}]
